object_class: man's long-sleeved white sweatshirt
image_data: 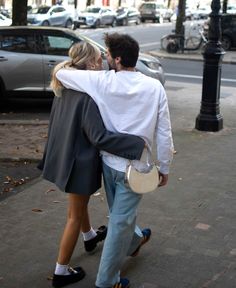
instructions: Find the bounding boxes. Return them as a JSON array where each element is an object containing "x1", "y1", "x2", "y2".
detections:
[{"x1": 56, "y1": 69, "x2": 173, "y2": 174}]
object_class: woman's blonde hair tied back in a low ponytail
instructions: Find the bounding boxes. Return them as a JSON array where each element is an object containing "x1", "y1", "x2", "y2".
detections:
[{"x1": 50, "y1": 41, "x2": 101, "y2": 96}]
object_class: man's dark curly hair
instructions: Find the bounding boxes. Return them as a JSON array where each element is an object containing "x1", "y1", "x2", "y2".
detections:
[{"x1": 104, "y1": 33, "x2": 139, "y2": 67}]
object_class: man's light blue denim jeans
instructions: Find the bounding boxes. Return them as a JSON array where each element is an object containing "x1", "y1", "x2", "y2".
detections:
[{"x1": 96, "y1": 163, "x2": 143, "y2": 288}]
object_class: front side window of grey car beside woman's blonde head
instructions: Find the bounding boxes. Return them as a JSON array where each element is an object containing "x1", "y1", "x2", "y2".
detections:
[{"x1": 43, "y1": 35, "x2": 78, "y2": 56}]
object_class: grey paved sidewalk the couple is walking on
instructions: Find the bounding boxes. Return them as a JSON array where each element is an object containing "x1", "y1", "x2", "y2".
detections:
[{"x1": 0, "y1": 77, "x2": 236, "y2": 288}]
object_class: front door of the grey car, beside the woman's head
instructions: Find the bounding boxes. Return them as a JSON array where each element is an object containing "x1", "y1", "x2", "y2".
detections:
[{"x1": 41, "y1": 31, "x2": 81, "y2": 92}]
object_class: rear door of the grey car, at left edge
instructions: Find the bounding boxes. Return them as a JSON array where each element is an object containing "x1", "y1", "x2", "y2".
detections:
[{"x1": 0, "y1": 29, "x2": 44, "y2": 96}]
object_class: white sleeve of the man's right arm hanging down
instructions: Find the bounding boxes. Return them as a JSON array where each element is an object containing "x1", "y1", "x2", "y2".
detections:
[{"x1": 156, "y1": 86, "x2": 174, "y2": 174}]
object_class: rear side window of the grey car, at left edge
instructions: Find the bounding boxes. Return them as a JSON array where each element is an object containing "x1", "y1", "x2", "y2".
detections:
[{"x1": 0, "y1": 35, "x2": 37, "y2": 53}]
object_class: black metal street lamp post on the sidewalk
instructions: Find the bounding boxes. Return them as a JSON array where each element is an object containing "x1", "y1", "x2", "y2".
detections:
[{"x1": 195, "y1": 0, "x2": 225, "y2": 132}]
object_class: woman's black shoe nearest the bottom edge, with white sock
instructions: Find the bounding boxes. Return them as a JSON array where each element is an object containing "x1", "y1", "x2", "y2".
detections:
[{"x1": 52, "y1": 267, "x2": 85, "y2": 288}]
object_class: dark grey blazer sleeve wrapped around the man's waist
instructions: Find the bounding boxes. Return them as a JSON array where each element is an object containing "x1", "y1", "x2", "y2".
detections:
[{"x1": 82, "y1": 98, "x2": 145, "y2": 160}]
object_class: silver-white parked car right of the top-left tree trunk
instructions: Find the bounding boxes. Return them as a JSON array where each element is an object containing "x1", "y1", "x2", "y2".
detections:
[{"x1": 27, "y1": 5, "x2": 74, "y2": 28}]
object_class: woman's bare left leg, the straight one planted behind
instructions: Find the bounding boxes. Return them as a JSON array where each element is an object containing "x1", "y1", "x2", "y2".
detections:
[{"x1": 57, "y1": 193, "x2": 90, "y2": 265}]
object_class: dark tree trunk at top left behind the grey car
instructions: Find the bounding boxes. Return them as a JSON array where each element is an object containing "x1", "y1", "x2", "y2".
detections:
[{"x1": 12, "y1": 0, "x2": 28, "y2": 26}]
